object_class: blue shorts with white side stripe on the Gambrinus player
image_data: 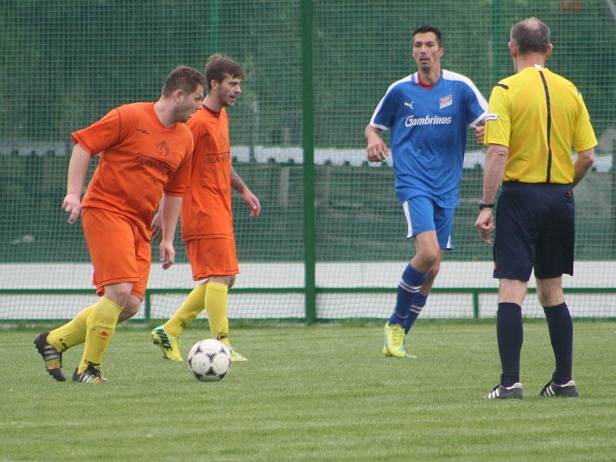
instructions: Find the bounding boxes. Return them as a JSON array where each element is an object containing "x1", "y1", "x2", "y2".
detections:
[{"x1": 402, "y1": 196, "x2": 454, "y2": 250}]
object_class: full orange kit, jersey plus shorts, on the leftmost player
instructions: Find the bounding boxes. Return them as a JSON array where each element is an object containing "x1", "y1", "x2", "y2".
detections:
[{"x1": 72, "y1": 103, "x2": 193, "y2": 299}]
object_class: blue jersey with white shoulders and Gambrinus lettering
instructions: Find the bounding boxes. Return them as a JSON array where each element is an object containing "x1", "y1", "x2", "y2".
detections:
[{"x1": 370, "y1": 70, "x2": 488, "y2": 208}]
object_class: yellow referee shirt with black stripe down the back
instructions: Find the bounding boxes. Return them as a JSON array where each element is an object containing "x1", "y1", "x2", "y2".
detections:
[{"x1": 484, "y1": 65, "x2": 597, "y2": 184}]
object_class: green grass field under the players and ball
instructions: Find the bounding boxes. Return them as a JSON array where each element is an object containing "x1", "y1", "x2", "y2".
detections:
[{"x1": 0, "y1": 321, "x2": 616, "y2": 461}]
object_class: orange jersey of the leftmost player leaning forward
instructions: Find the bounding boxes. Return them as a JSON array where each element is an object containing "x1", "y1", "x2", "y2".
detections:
[{"x1": 71, "y1": 103, "x2": 193, "y2": 238}]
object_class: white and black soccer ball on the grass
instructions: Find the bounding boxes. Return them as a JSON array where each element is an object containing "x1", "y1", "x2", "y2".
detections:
[{"x1": 188, "y1": 339, "x2": 231, "y2": 382}]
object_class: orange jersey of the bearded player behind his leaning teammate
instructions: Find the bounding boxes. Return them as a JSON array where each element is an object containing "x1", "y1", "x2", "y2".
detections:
[{"x1": 181, "y1": 106, "x2": 234, "y2": 241}]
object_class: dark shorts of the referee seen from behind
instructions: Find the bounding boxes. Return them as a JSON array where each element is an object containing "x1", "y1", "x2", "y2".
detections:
[{"x1": 492, "y1": 182, "x2": 575, "y2": 281}]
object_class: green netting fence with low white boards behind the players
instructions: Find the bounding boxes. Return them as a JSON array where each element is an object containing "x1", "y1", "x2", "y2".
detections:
[{"x1": 0, "y1": 0, "x2": 616, "y2": 321}]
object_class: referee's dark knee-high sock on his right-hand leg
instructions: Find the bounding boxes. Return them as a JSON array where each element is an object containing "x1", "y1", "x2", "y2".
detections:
[{"x1": 543, "y1": 303, "x2": 573, "y2": 385}]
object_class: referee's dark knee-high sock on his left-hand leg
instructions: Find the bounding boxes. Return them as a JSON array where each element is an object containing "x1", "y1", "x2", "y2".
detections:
[{"x1": 496, "y1": 303, "x2": 524, "y2": 387}]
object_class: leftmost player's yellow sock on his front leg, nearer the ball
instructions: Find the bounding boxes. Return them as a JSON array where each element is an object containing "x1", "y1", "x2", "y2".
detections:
[{"x1": 77, "y1": 297, "x2": 122, "y2": 373}]
